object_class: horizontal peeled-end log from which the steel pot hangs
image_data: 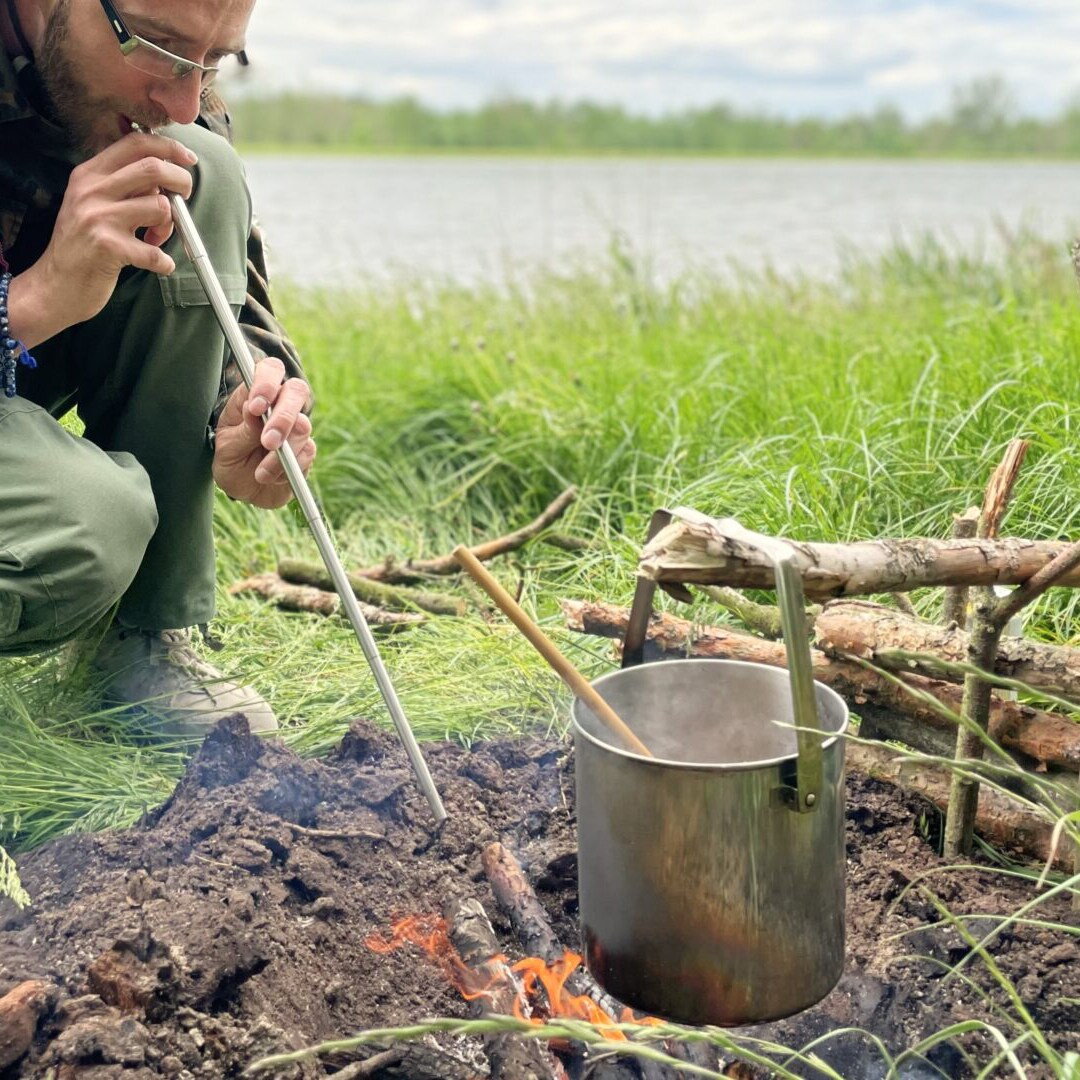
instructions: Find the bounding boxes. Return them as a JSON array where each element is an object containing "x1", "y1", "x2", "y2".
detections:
[{"x1": 638, "y1": 509, "x2": 1080, "y2": 599}]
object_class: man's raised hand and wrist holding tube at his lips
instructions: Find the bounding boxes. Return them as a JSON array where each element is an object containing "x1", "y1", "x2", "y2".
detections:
[{"x1": 10, "y1": 133, "x2": 197, "y2": 348}]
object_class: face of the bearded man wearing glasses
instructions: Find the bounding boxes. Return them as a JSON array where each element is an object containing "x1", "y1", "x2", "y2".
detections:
[{"x1": 36, "y1": 0, "x2": 254, "y2": 154}]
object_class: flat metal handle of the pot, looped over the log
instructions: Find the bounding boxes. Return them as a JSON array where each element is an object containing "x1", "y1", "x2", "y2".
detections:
[{"x1": 622, "y1": 507, "x2": 824, "y2": 813}]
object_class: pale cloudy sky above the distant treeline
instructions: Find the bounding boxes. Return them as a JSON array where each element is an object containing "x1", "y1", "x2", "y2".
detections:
[{"x1": 217, "y1": 0, "x2": 1080, "y2": 120}]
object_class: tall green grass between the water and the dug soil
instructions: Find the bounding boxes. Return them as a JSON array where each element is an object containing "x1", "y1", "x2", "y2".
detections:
[{"x1": 0, "y1": 238, "x2": 1080, "y2": 847}]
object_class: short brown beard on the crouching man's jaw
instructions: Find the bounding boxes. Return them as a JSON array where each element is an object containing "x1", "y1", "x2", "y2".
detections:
[{"x1": 36, "y1": 0, "x2": 168, "y2": 156}]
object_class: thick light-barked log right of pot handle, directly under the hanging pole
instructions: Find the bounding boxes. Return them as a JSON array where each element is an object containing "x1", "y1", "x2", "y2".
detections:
[{"x1": 814, "y1": 600, "x2": 1080, "y2": 701}]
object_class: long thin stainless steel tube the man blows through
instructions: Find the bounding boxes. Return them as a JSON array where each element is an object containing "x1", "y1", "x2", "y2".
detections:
[{"x1": 160, "y1": 181, "x2": 446, "y2": 822}]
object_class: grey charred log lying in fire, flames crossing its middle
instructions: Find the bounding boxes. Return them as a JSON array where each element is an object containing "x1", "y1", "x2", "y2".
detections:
[{"x1": 443, "y1": 900, "x2": 563, "y2": 1080}]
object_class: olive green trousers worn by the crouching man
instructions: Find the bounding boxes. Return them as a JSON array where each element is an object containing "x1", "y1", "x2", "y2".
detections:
[{"x1": 0, "y1": 125, "x2": 251, "y2": 653}]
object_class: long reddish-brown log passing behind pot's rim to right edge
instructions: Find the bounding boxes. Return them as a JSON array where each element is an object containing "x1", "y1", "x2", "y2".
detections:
[{"x1": 562, "y1": 600, "x2": 1080, "y2": 772}]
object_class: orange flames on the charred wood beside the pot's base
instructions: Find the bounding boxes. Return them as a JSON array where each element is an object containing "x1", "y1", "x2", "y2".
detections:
[{"x1": 364, "y1": 915, "x2": 650, "y2": 1039}]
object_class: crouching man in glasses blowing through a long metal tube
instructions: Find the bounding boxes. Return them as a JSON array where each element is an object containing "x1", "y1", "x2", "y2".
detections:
[{"x1": 0, "y1": 0, "x2": 315, "y2": 734}]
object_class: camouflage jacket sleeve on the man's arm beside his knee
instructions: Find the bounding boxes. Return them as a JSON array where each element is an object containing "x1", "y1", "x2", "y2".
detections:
[{"x1": 199, "y1": 87, "x2": 313, "y2": 431}]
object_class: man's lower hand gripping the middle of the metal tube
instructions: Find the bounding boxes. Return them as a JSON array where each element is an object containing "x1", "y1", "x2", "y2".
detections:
[{"x1": 214, "y1": 357, "x2": 315, "y2": 510}]
